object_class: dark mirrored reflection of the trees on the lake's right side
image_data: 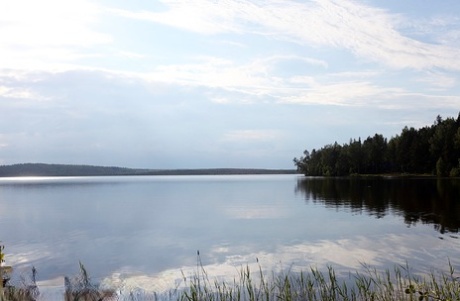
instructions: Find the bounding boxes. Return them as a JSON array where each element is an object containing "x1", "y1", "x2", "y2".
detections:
[{"x1": 296, "y1": 177, "x2": 460, "y2": 233}]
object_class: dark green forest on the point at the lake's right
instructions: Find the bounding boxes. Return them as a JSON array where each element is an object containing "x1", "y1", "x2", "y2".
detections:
[{"x1": 294, "y1": 113, "x2": 460, "y2": 177}]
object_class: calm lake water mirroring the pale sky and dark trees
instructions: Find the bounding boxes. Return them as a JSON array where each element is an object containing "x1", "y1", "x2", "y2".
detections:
[{"x1": 0, "y1": 175, "x2": 460, "y2": 292}]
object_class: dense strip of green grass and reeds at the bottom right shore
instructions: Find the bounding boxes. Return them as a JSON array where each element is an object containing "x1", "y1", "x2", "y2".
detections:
[{"x1": 178, "y1": 262, "x2": 460, "y2": 301}]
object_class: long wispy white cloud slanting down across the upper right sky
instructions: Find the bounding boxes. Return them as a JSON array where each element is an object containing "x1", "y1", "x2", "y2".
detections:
[{"x1": 116, "y1": 0, "x2": 460, "y2": 70}]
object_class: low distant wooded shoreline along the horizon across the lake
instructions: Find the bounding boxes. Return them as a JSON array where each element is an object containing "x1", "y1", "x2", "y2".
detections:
[{"x1": 0, "y1": 163, "x2": 298, "y2": 177}]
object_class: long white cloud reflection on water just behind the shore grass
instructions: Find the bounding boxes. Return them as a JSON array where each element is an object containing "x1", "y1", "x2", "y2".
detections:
[{"x1": 99, "y1": 234, "x2": 460, "y2": 292}]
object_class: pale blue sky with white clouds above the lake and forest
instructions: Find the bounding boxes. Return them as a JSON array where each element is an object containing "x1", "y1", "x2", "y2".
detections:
[{"x1": 0, "y1": 0, "x2": 460, "y2": 169}]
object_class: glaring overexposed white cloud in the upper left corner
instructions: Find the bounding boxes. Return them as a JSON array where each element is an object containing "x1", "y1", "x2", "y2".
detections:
[{"x1": 0, "y1": 0, "x2": 111, "y2": 70}]
